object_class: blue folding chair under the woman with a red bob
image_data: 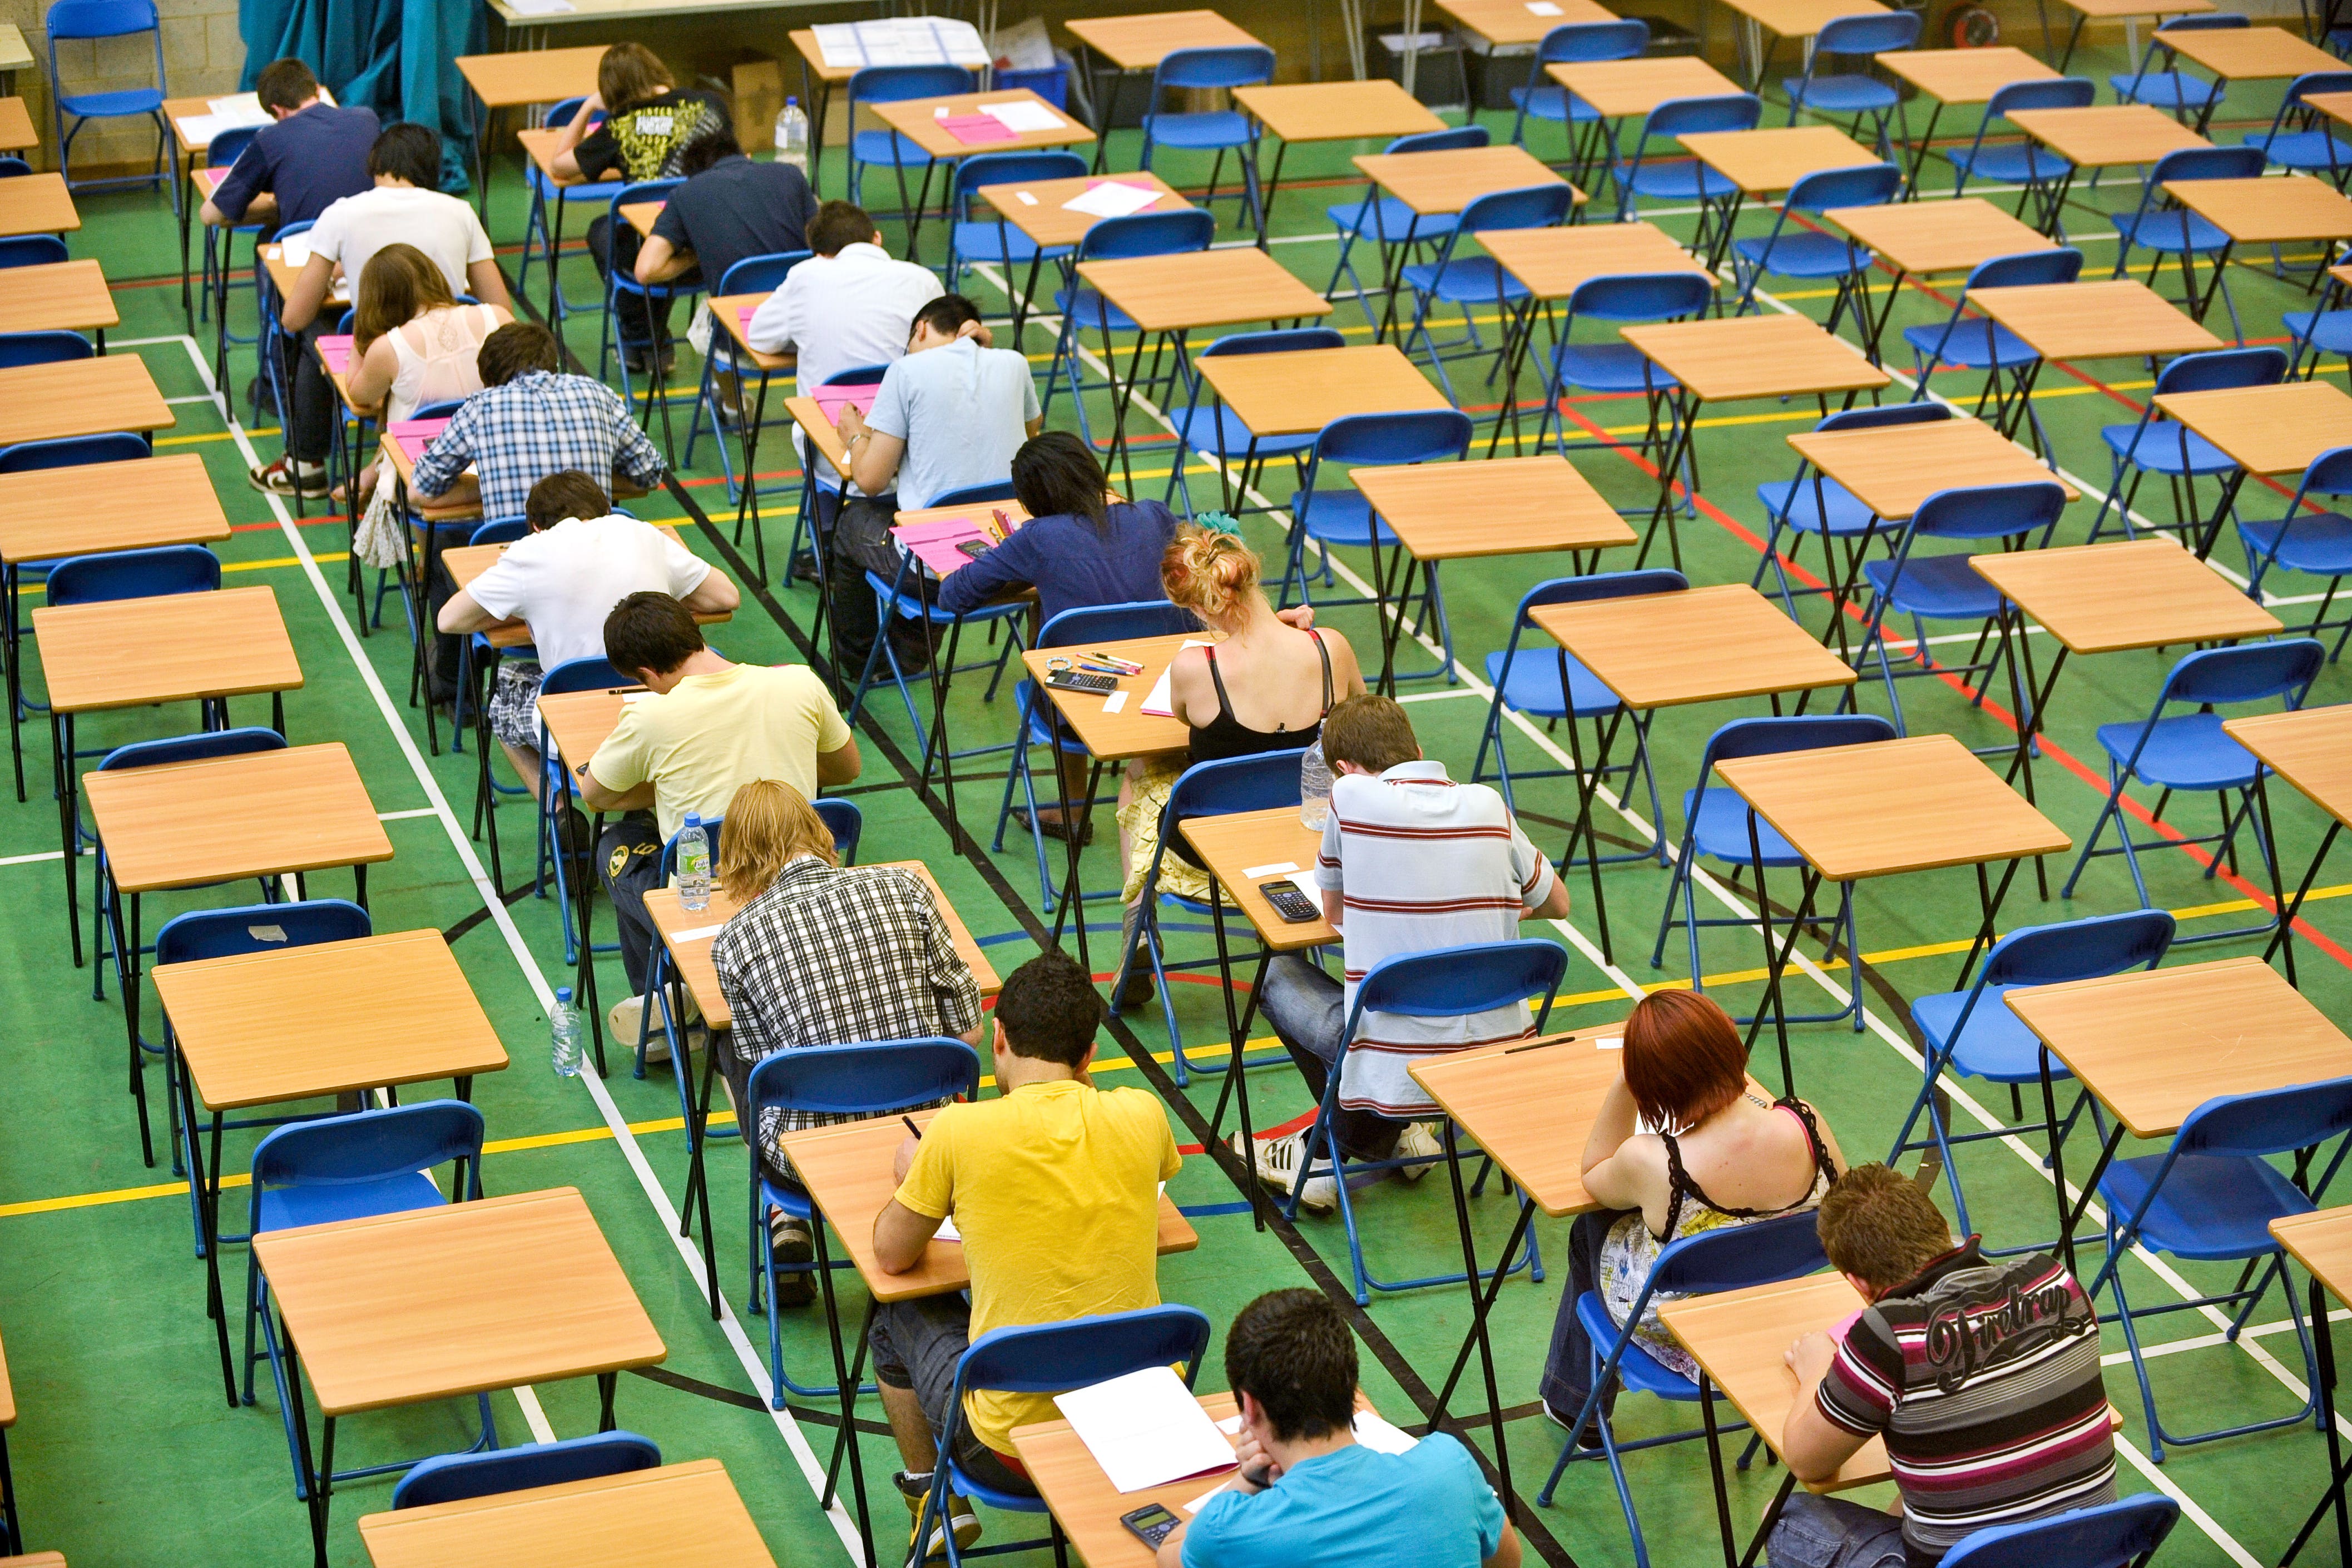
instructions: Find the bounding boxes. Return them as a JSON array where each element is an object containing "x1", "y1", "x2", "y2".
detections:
[{"x1": 1536, "y1": 1210, "x2": 1830, "y2": 1568}]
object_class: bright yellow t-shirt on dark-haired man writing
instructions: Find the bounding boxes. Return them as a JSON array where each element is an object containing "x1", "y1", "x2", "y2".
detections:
[{"x1": 898, "y1": 1079, "x2": 1183, "y2": 1453}]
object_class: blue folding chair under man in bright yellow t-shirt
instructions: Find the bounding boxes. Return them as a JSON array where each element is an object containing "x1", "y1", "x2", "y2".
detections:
[{"x1": 915, "y1": 1304, "x2": 1209, "y2": 1568}]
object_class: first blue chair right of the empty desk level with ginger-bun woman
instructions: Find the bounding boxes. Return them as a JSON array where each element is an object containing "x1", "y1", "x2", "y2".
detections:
[{"x1": 1846, "y1": 479, "x2": 2065, "y2": 757}]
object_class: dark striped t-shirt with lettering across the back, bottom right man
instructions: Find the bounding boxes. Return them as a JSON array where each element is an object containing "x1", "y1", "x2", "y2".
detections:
[{"x1": 1816, "y1": 1237, "x2": 2115, "y2": 1568}]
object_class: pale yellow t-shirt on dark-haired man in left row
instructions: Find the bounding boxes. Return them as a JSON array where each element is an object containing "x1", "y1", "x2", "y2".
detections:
[{"x1": 588, "y1": 665, "x2": 849, "y2": 839}]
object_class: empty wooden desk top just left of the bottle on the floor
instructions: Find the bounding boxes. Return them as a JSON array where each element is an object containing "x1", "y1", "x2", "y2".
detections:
[{"x1": 151, "y1": 931, "x2": 506, "y2": 1110}]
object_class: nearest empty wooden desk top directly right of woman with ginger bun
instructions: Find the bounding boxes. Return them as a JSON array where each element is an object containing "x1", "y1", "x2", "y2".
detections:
[{"x1": 1519, "y1": 583, "x2": 1856, "y2": 710}]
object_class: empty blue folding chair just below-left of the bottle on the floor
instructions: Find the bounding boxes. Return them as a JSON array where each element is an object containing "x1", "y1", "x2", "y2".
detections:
[{"x1": 245, "y1": 1100, "x2": 499, "y2": 1500}]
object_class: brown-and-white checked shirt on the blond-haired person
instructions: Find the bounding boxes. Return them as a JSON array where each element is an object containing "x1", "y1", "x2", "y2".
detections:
[{"x1": 710, "y1": 856, "x2": 981, "y2": 1164}]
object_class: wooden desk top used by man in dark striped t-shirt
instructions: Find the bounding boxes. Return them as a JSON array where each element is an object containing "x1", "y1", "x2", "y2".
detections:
[{"x1": 1658, "y1": 1274, "x2": 1893, "y2": 1493}]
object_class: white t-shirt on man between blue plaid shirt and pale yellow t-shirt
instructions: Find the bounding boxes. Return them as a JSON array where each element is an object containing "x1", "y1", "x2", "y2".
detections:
[{"x1": 468, "y1": 513, "x2": 710, "y2": 670}]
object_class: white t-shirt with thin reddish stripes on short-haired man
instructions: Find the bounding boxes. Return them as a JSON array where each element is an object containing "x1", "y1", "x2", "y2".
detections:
[{"x1": 1315, "y1": 762, "x2": 1552, "y2": 1117}]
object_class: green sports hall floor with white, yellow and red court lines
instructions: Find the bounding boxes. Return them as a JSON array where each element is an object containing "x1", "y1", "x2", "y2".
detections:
[{"x1": 13, "y1": 49, "x2": 2352, "y2": 1568}]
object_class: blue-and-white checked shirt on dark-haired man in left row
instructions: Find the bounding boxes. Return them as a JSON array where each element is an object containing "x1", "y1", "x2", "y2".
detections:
[{"x1": 409, "y1": 369, "x2": 661, "y2": 519}]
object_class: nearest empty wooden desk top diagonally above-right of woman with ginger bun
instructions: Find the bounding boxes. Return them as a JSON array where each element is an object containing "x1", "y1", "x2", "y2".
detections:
[{"x1": 1348, "y1": 446, "x2": 1640, "y2": 562}]
